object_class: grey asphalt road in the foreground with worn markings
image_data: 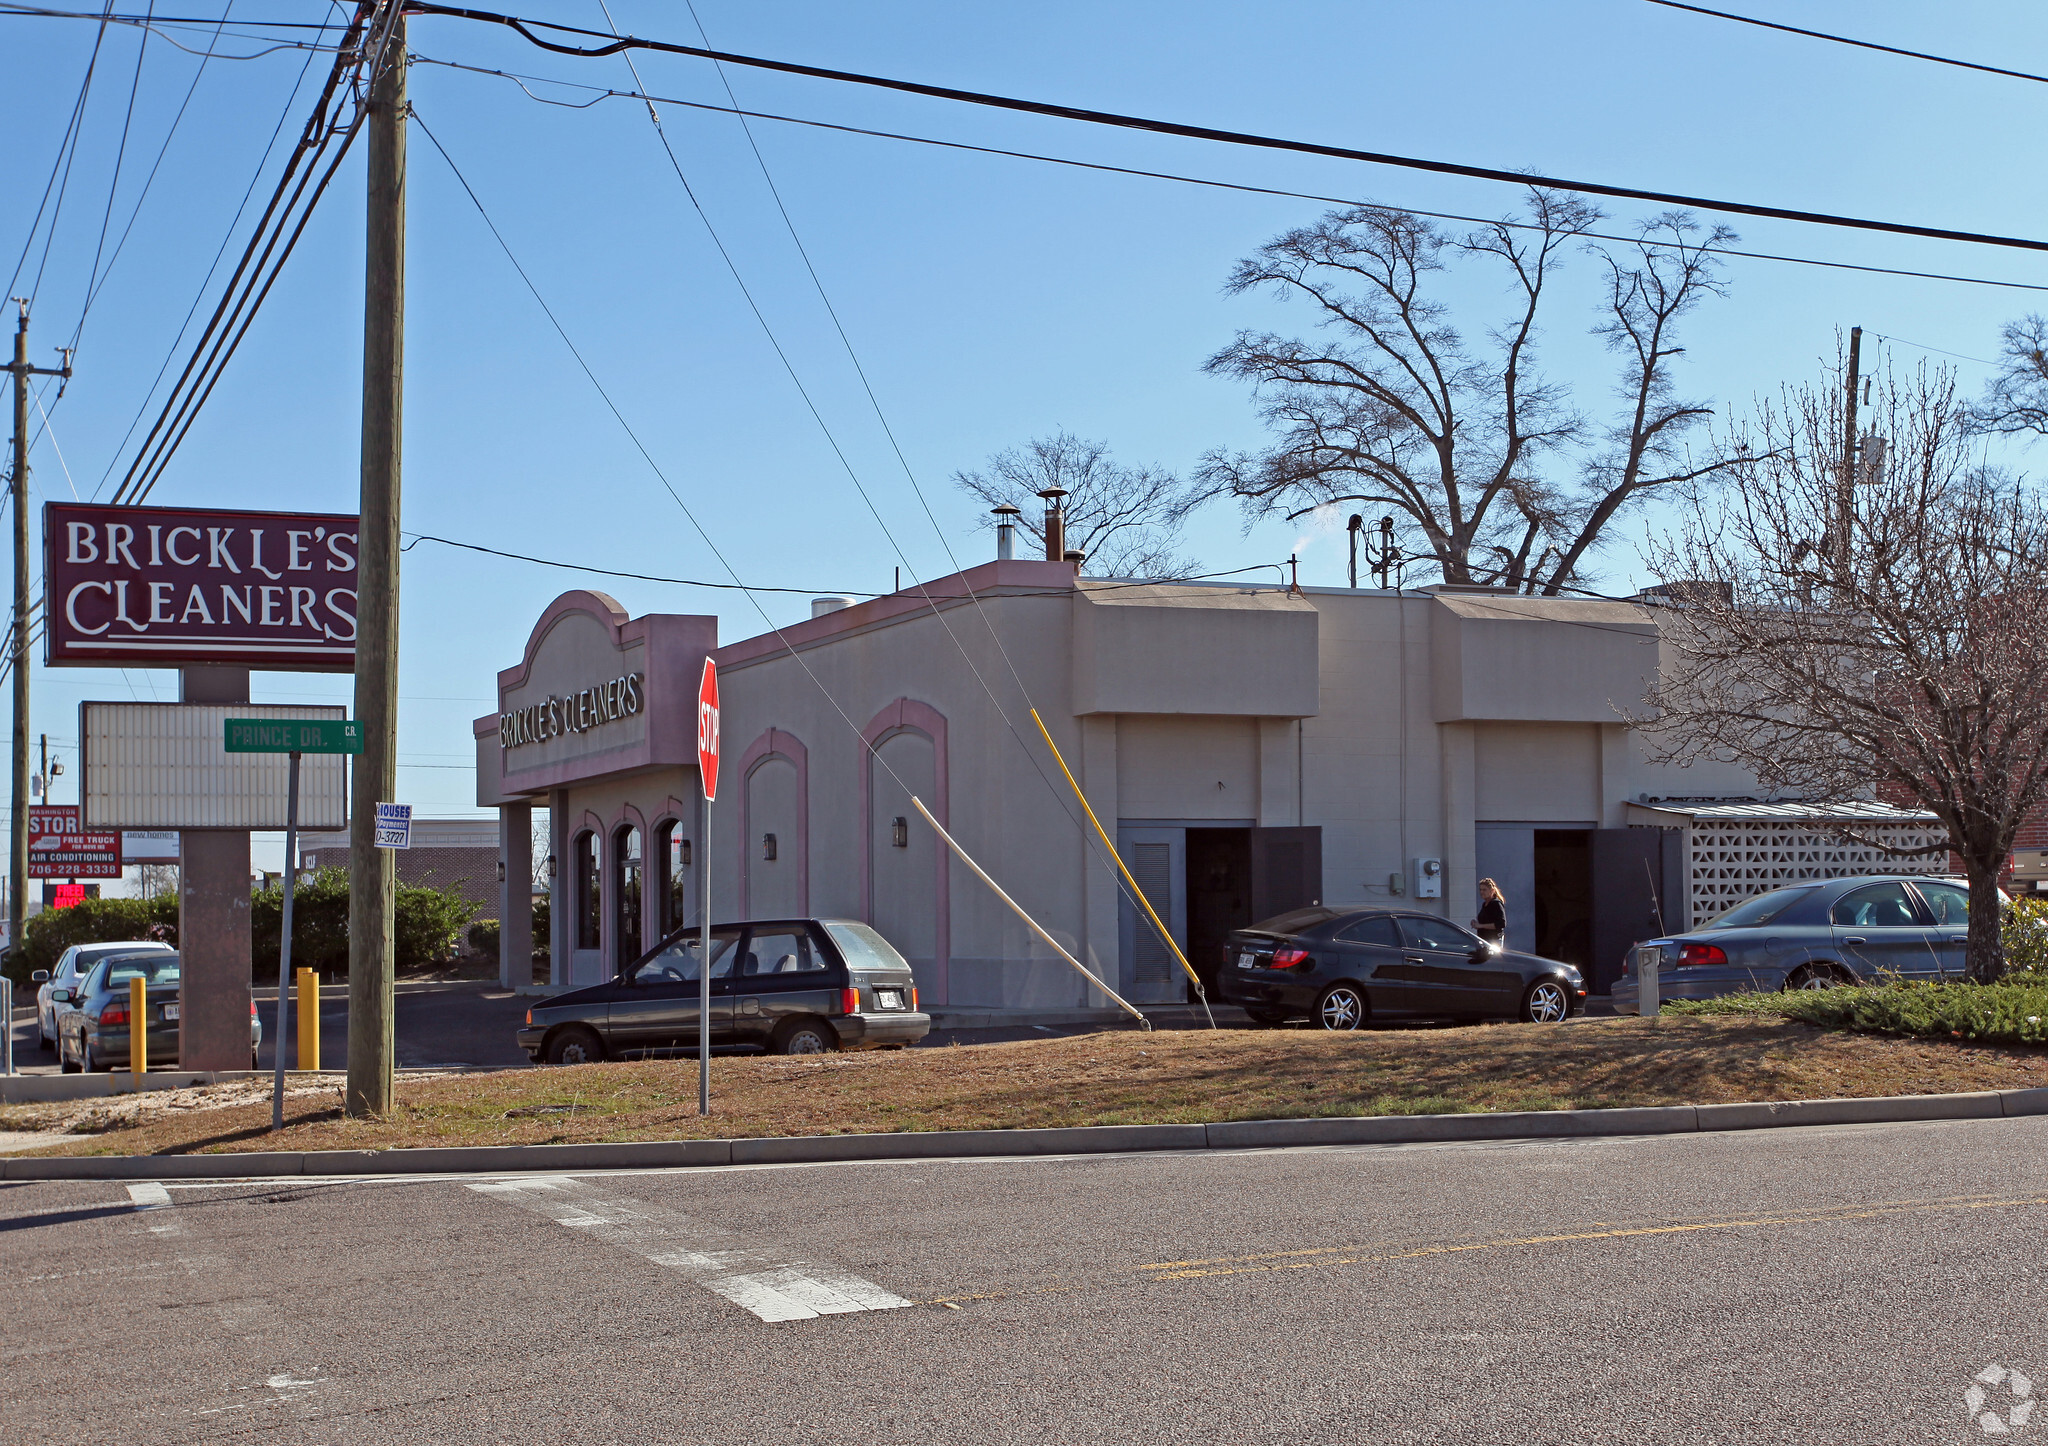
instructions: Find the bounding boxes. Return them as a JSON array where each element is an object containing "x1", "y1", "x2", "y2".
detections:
[{"x1": 0, "y1": 1120, "x2": 2048, "y2": 1446}]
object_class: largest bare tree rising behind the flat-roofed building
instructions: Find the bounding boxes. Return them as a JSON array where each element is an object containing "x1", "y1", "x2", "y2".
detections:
[{"x1": 1200, "y1": 186, "x2": 1735, "y2": 594}]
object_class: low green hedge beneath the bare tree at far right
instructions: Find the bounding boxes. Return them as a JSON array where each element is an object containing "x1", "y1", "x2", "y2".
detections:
[{"x1": 1663, "y1": 973, "x2": 2048, "y2": 1045}]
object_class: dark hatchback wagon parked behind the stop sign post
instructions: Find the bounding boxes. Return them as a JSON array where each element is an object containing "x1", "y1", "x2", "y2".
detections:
[{"x1": 518, "y1": 920, "x2": 932, "y2": 1065}]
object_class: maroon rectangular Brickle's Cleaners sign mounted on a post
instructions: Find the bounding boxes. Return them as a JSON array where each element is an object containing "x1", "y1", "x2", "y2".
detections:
[{"x1": 43, "y1": 502, "x2": 356, "y2": 672}]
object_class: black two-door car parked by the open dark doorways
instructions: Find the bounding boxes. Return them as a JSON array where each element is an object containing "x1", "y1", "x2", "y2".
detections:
[{"x1": 1217, "y1": 907, "x2": 1585, "y2": 1030}]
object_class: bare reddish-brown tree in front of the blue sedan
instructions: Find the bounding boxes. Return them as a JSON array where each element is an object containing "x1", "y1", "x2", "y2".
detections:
[{"x1": 1642, "y1": 360, "x2": 2048, "y2": 981}]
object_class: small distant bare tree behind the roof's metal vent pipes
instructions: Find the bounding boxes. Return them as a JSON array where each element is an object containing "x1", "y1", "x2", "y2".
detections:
[{"x1": 952, "y1": 432, "x2": 1200, "y2": 578}]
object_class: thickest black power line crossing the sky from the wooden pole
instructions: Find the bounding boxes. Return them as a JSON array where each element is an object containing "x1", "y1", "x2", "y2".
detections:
[{"x1": 408, "y1": 0, "x2": 2048, "y2": 252}]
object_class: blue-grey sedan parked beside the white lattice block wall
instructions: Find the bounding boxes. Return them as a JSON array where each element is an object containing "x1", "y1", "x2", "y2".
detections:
[{"x1": 1612, "y1": 875, "x2": 1970, "y2": 1014}]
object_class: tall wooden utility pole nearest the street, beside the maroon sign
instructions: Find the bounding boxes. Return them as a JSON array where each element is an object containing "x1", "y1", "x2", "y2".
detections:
[{"x1": 346, "y1": 0, "x2": 408, "y2": 1118}]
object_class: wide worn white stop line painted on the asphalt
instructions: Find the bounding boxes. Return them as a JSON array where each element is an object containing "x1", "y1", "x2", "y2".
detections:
[{"x1": 467, "y1": 1176, "x2": 911, "y2": 1321}]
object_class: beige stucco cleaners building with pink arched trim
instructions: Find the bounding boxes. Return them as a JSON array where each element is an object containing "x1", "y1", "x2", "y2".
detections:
[{"x1": 475, "y1": 559, "x2": 1785, "y2": 1010}]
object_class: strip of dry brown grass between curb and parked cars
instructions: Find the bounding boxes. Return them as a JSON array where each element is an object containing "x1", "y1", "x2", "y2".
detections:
[{"x1": 0, "y1": 1016, "x2": 2048, "y2": 1155}]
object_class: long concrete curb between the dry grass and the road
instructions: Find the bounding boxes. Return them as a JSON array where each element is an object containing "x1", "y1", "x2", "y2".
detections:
[{"x1": 0, "y1": 1088, "x2": 2048, "y2": 1180}]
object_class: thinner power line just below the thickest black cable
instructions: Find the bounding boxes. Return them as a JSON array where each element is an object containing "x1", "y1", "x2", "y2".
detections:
[{"x1": 410, "y1": 53, "x2": 2048, "y2": 291}]
